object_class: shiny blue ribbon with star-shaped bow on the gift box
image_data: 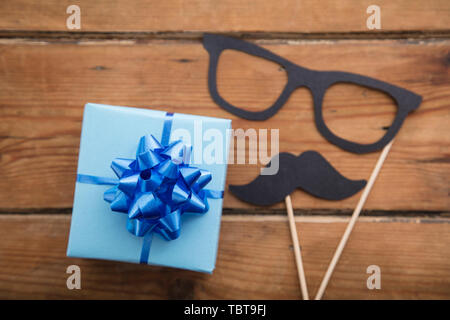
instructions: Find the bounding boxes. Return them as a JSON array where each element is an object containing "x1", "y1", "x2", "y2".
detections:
[{"x1": 77, "y1": 113, "x2": 223, "y2": 264}]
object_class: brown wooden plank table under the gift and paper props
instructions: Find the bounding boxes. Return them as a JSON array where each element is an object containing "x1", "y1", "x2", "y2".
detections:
[{"x1": 0, "y1": 0, "x2": 450, "y2": 299}]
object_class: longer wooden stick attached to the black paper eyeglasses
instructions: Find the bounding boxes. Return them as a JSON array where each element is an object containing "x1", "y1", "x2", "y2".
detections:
[{"x1": 315, "y1": 140, "x2": 394, "y2": 300}]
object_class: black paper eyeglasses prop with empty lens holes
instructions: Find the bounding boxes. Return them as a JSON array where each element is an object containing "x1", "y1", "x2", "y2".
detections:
[{"x1": 203, "y1": 34, "x2": 422, "y2": 153}]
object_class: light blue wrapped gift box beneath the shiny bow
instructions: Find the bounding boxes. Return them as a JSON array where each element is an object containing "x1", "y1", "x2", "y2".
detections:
[{"x1": 67, "y1": 103, "x2": 231, "y2": 273}]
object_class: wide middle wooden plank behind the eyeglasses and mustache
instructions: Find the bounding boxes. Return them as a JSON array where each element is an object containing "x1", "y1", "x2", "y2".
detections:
[{"x1": 0, "y1": 40, "x2": 450, "y2": 211}]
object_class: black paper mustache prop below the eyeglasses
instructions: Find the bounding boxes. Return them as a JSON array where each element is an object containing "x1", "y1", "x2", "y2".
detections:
[{"x1": 229, "y1": 151, "x2": 366, "y2": 206}]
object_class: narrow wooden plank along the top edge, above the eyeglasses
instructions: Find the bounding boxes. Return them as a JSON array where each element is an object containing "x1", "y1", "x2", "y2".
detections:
[{"x1": 0, "y1": 0, "x2": 450, "y2": 33}]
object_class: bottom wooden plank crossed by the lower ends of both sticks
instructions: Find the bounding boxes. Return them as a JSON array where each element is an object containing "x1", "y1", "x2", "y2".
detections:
[{"x1": 0, "y1": 215, "x2": 450, "y2": 299}]
